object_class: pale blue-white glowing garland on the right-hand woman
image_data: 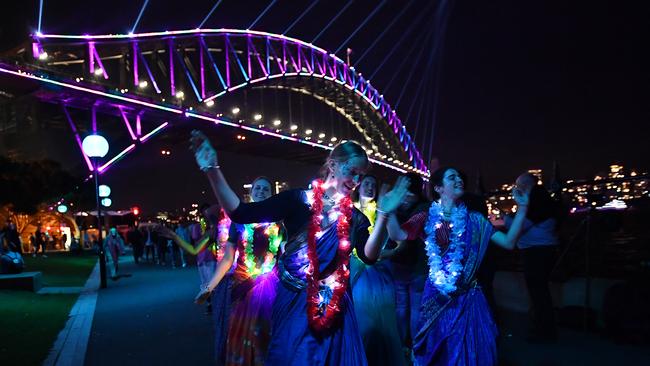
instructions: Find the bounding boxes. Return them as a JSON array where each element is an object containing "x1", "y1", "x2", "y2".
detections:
[{"x1": 424, "y1": 201, "x2": 467, "y2": 295}]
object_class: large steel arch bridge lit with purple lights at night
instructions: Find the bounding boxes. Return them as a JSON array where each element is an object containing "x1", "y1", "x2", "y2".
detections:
[{"x1": 0, "y1": 2, "x2": 444, "y2": 177}]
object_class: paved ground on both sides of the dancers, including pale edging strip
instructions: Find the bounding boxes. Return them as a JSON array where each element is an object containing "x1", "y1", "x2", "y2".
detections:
[{"x1": 45, "y1": 253, "x2": 650, "y2": 366}]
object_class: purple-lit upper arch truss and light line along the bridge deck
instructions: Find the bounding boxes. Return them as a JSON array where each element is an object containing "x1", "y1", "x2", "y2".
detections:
[{"x1": 25, "y1": 29, "x2": 428, "y2": 176}]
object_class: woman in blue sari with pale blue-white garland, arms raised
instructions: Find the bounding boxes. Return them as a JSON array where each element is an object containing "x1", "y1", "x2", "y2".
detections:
[{"x1": 388, "y1": 167, "x2": 529, "y2": 366}]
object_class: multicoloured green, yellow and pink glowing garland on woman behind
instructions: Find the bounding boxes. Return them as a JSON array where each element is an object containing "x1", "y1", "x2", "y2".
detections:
[{"x1": 240, "y1": 224, "x2": 282, "y2": 278}]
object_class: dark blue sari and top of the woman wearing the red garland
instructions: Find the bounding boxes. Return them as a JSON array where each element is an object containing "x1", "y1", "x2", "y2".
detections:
[{"x1": 231, "y1": 190, "x2": 370, "y2": 366}]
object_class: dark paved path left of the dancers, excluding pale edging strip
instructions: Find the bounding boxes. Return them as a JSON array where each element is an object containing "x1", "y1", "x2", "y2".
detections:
[{"x1": 85, "y1": 256, "x2": 214, "y2": 366}]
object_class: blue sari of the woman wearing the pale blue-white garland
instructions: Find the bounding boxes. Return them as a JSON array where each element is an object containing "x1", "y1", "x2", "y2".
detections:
[{"x1": 413, "y1": 212, "x2": 497, "y2": 366}]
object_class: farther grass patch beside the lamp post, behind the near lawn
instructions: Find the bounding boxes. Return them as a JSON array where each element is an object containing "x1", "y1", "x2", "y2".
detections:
[{"x1": 23, "y1": 252, "x2": 97, "y2": 287}]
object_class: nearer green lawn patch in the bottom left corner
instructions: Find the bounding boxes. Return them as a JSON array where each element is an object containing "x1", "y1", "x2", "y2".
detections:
[{"x1": 0, "y1": 290, "x2": 79, "y2": 365}]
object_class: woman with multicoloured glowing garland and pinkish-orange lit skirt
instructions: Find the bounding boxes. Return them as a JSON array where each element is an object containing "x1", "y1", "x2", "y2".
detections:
[{"x1": 197, "y1": 177, "x2": 285, "y2": 365}]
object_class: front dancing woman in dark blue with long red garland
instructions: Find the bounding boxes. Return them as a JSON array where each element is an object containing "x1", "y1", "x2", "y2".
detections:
[{"x1": 192, "y1": 131, "x2": 408, "y2": 365}]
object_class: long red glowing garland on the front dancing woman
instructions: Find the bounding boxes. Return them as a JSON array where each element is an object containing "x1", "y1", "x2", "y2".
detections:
[{"x1": 306, "y1": 180, "x2": 353, "y2": 331}]
